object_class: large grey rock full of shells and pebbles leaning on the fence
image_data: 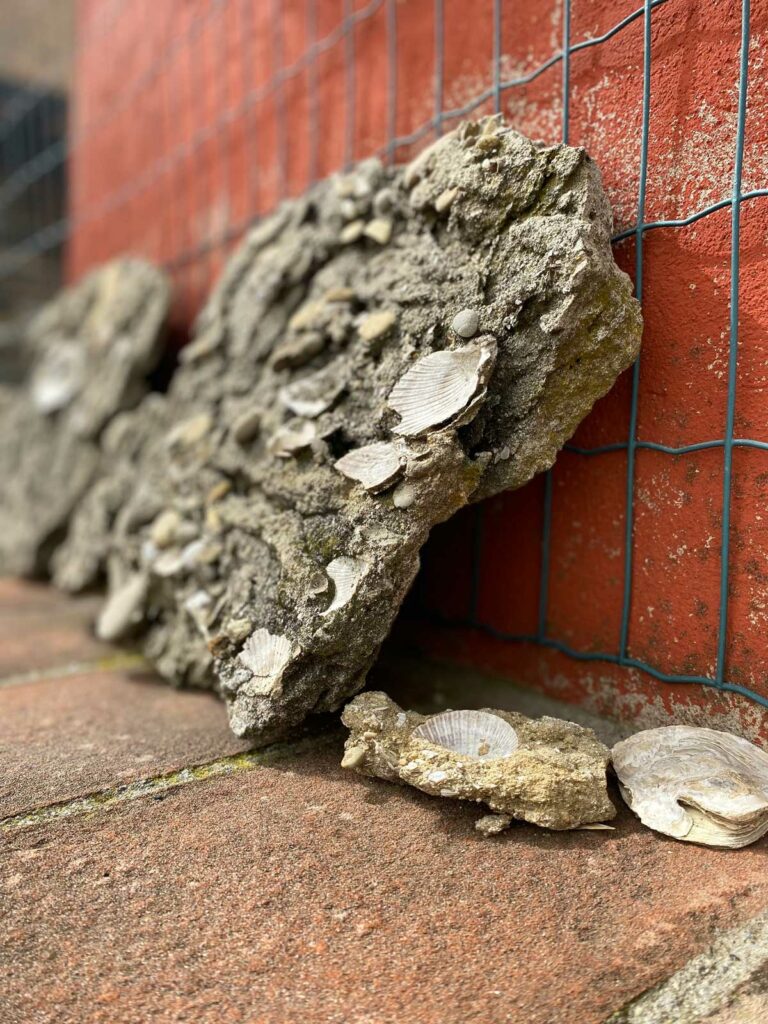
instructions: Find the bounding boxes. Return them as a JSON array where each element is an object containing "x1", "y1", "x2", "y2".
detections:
[{"x1": 93, "y1": 119, "x2": 641, "y2": 738}]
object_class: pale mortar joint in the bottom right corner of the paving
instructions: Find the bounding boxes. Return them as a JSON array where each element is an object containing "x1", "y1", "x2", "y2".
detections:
[{"x1": 605, "y1": 909, "x2": 768, "y2": 1024}]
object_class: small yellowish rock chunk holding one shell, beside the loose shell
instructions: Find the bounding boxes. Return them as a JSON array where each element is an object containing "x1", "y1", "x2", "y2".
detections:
[{"x1": 341, "y1": 691, "x2": 615, "y2": 836}]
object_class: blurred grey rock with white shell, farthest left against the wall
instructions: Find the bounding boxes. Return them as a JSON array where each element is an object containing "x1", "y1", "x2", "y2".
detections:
[{"x1": 0, "y1": 259, "x2": 169, "y2": 575}]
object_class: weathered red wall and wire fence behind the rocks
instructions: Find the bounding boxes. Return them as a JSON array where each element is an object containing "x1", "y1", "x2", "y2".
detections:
[{"x1": 0, "y1": 0, "x2": 768, "y2": 728}]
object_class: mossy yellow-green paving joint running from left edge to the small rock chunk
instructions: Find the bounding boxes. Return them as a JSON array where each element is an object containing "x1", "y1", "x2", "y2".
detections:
[{"x1": 0, "y1": 729, "x2": 341, "y2": 835}]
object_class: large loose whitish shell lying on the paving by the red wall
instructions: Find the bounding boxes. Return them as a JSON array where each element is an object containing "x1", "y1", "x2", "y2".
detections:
[{"x1": 612, "y1": 725, "x2": 768, "y2": 847}]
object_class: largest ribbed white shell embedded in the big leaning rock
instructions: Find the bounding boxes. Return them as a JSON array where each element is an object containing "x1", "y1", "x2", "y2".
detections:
[{"x1": 388, "y1": 343, "x2": 496, "y2": 436}]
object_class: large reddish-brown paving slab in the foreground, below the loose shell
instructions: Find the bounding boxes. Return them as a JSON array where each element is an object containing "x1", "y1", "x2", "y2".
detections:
[{"x1": 0, "y1": 743, "x2": 768, "y2": 1024}]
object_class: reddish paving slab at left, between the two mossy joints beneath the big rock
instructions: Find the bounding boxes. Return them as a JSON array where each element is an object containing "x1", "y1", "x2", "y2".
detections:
[{"x1": 0, "y1": 672, "x2": 249, "y2": 817}]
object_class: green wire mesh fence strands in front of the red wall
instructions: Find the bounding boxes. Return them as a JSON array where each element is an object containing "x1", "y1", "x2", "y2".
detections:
[{"x1": 0, "y1": 0, "x2": 768, "y2": 708}]
